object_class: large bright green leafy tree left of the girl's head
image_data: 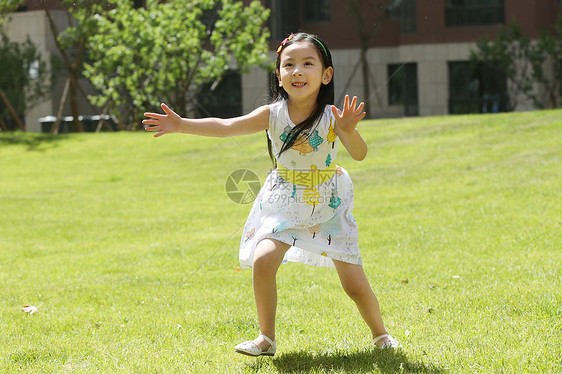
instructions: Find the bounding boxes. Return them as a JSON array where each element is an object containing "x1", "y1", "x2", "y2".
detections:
[{"x1": 85, "y1": 0, "x2": 269, "y2": 127}]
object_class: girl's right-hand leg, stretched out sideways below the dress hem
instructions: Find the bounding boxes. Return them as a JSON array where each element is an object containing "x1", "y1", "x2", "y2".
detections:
[{"x1": 333, "y1": 260, "x2": 388, "y2": 345}]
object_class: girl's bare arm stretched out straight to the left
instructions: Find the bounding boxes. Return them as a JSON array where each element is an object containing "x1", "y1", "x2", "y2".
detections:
[{"x1": 142, "y1": 104, "x2": 269, "y2": 138}]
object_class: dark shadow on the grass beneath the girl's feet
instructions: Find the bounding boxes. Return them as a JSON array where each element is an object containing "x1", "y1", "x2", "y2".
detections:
[{"x1": 249, "y1": 348, "x2": 447, "y2": 374}]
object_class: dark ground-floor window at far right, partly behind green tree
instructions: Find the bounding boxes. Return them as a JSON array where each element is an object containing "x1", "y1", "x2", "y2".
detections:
[{"x1": 448, "y1": 61, "x2": 508, "y2": 114}]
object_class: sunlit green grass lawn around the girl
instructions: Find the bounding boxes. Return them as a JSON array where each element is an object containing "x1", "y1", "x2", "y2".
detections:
[{"x1": 0, "y1": 111, "x2": 562, "y2": 373}]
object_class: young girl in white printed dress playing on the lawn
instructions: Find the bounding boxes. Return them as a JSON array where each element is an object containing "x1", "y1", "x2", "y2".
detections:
[{"x1": 143, "y1": 33, "x2": 399, "y2": 356}]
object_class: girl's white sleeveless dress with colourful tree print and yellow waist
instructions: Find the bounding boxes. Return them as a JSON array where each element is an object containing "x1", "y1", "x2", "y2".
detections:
[{"x1": 236, "y1": 100, "x2": 361, "y2": 268}]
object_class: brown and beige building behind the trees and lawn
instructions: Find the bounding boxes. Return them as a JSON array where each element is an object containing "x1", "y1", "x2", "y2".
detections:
[{"x1": 2, "y1": 0, "x2": 562, "y2": 131}]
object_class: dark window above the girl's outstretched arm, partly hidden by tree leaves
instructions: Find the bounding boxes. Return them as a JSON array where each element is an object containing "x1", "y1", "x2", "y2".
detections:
[{"x1": 198, "y1": 71, "x2": 242, "y2": 118}]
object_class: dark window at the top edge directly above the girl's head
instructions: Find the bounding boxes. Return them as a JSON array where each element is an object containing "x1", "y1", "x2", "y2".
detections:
[{"x1": 266, "y1": 0, "x2": 300, "y2": 43}]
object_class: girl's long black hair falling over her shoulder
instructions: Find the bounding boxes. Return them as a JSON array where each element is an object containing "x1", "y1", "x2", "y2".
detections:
[{"x1": 267, "y1": 32, "x2": 335, "y2": 167}]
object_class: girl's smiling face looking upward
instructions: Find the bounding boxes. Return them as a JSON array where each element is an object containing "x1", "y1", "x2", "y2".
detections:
[{"x1": 277, "y1": 42, "x2": 334, "y2": 100}]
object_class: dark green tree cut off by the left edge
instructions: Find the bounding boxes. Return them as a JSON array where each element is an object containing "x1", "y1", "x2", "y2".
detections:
[{"x1": 0, "y1": 29, "x2": 49, "y2": 131}]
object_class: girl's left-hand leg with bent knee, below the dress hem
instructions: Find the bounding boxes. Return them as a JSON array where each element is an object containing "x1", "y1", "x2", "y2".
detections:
[{"x1": 253, "y1": 239, "x2": 291, "y2": 349}]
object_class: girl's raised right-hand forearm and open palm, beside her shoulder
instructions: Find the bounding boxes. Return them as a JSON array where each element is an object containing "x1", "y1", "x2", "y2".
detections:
[{"x1": 332, "y1": 95, "x2": 367, "y2": 161}]
